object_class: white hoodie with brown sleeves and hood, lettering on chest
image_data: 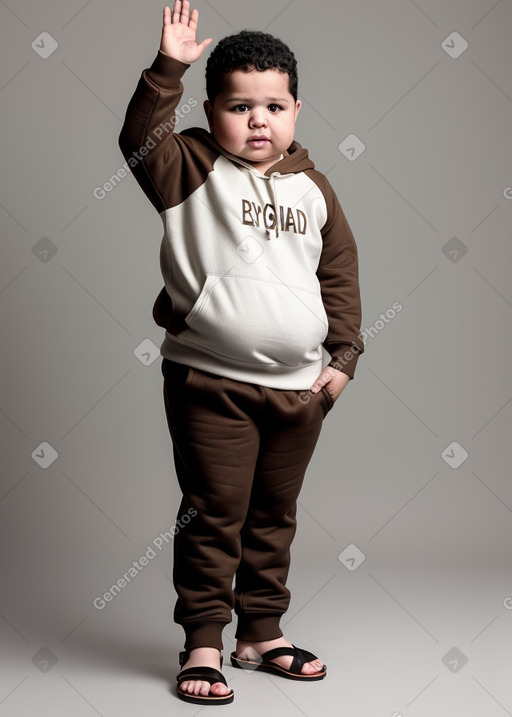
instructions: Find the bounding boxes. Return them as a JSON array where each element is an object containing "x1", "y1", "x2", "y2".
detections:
[{"x1": 119, "y1": 50, "x2": 364, "y2": 390}]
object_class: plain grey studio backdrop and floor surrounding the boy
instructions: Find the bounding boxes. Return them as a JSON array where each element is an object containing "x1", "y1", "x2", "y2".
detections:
[{"x1": 0, "y1": 0, "x2": 512, "y2": 717}]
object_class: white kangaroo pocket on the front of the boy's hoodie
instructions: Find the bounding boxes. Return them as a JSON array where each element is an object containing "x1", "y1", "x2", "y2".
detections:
[{"x1": 177, "y1": 274, "x2": 328, "y2": 366}]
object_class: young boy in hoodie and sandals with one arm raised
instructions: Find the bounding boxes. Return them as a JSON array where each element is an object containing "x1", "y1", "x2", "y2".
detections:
[{"x1": 119, "y1": 0, "x2": 364, "y2": 704}]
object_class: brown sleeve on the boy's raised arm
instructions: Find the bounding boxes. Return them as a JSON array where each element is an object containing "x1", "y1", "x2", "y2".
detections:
[{"x1": 118, "y1": 50, "x2": 217, "y2": 213}]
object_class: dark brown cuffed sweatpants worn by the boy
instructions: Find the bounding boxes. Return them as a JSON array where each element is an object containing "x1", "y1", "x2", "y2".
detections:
[{"x1": 162, "y1": 358, "x2": 333, "y2": 650}]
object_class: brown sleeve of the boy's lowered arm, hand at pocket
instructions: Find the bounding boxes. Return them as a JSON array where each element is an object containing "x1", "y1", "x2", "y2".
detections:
[{"x1": 310, "y1": 171, "x2": 364, "y2": 379}]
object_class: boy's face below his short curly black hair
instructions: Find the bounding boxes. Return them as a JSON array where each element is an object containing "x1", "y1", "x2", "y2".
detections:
[{"x1": 204, "y1": 69, "x2": 301, "y2": 172}]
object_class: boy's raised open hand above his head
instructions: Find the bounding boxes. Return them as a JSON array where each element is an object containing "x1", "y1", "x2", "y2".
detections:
[{"x1": 160, "y1": 0, "x2": 213, "y2": 64}]
